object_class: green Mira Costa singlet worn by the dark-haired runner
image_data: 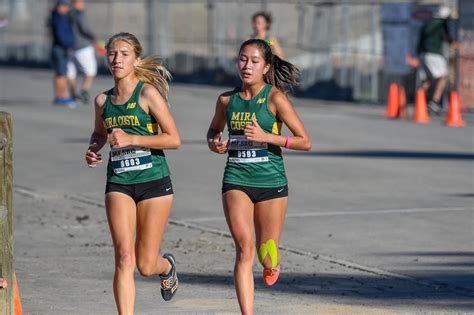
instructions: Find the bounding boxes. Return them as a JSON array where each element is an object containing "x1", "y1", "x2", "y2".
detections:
[{"x1": 223, "y1": 84, "x2": 288, "y2": 188}]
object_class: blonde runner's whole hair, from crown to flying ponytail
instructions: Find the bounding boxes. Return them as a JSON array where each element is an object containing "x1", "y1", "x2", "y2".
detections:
[{"x1": 105, "y1": 32, "x2": 171, "y2": 102}]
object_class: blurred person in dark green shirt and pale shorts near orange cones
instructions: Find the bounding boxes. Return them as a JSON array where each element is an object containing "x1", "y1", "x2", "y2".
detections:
[{"x1": 417, "y1": 6, "x2": 453, "y2": 114}]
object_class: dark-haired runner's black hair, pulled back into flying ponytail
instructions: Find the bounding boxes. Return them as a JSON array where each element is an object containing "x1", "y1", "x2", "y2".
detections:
[{"x1": 239, "y1": 38, "x2": 300, "y2": 93}]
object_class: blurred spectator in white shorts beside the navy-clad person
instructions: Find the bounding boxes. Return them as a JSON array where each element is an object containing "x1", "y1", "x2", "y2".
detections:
[{"x1": 67, "y1": 0, "x2": 97, "y2": 104}]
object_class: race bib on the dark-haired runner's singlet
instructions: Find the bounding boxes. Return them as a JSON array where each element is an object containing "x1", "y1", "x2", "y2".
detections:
[{"x1": 228, "y1": 135, "x2": 268, "y2": 163}]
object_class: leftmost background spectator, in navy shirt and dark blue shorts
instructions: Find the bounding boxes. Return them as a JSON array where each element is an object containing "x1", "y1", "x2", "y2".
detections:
[{"x1": 50, "y1": 0, "x2": 76, "y2": 107}]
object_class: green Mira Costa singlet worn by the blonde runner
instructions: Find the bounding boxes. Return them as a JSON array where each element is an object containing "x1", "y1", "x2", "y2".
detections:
[{"x1": 102, "y1": 81, "x2": 170, "y2": 184}]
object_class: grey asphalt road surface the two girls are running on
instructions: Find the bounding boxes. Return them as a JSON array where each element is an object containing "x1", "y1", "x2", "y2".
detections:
[{"x1": 0, "y1": 68, "x2": 474, "y2": 314}]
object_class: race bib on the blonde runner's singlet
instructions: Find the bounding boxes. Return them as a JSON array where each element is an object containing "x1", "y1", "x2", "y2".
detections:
[{"x1": 110, "y1": 147, "x2": 153, "y2": 174}]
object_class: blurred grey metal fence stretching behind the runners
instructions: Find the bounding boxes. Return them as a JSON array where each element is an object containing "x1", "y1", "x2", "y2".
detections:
[{"x1": 0, "y1": 0, "x2": 455, "y2": 102}]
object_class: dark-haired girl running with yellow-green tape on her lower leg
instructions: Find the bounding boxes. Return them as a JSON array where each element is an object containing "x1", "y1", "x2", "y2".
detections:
[{"x1": 207, "y1": 39, "x2": 311, "y2": 314}]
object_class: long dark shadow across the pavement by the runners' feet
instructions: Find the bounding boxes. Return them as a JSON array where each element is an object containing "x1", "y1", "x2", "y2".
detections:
[{"x1": 137, "y1": 272, "x2": 474, "y2": 311}]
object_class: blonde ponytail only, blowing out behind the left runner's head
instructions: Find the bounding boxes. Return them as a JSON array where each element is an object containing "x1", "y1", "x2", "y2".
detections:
[{"x1": 135, "y1": 56, "x2": 171, "y2": 103}]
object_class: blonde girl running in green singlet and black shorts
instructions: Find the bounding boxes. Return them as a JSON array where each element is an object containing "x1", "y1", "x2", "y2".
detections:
[{"x1": 85, "y1": 33, "x2": 181, "y2": 314}]
